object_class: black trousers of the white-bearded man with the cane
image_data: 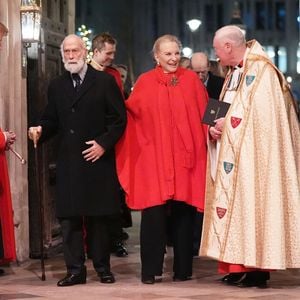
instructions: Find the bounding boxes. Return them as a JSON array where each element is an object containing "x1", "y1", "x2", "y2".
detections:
[{"x1": 59, "y1": 216, "x2": 111, "y2": 274}]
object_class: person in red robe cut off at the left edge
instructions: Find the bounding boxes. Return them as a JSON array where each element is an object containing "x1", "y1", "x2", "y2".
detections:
[{"x1": 0, "y1": 22, "x2": 16, "y2": 275}]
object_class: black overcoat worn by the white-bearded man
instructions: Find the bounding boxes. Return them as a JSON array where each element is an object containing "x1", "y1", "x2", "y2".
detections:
[{"x1": 40, "y1": 66, "x2": 126, "y2": 217}]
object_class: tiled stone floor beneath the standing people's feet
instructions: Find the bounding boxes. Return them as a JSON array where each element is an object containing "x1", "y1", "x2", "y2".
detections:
[{"x1": 0, "y1": 213, "x2": 300, "y2": 300}]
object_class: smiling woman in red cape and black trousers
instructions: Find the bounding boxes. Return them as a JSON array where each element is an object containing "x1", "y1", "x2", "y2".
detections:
[{"x1": 117, "y1": 35, "x2": 207, "y2": 284}]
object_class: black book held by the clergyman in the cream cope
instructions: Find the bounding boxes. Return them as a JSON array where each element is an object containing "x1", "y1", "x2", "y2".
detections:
[{"x1": 202, "y1": 98, "x2": 230, "y2": 126}]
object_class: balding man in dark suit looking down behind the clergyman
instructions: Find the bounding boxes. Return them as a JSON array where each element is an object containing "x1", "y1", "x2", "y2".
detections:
[{"x1": 191, "y1": 52, "x2": 224, "y2": 99}]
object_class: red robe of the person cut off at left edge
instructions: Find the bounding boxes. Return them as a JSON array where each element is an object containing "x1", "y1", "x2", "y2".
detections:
[{"x1": 0, "y1": 130, "x2": 16, "y2": 263}]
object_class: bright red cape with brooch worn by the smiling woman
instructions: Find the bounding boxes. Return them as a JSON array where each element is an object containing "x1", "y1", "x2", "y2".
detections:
[{"x1": 116, "y1": 67, "x2": 207, "y2": 211}]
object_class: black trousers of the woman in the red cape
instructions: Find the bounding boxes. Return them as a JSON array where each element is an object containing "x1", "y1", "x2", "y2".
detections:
[{"x1": 140, "y1": 201, "x2": 196, "y2": 278}]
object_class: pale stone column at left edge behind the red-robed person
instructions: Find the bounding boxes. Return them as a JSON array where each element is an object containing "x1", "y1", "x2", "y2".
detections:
[{"x1": 0, "y1": 0, "x2": 29, "y2": 261}]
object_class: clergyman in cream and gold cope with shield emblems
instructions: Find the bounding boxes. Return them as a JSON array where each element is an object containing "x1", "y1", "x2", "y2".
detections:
[{"x1": 200, "y1": 26, "x2": 300, "y2": 288}]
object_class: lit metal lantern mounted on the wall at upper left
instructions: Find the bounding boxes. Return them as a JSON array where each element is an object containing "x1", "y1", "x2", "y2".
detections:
[{"x1": 20, "y1": 0, "x2": 42, "y2": 44}]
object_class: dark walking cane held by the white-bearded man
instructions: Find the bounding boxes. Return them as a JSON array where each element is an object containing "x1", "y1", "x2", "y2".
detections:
[{"x1": 33, "y1": 132, "x2": 46, "y2": 281}]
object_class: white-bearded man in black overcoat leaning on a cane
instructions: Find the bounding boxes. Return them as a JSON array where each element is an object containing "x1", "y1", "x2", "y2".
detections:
[{"x1": 29, "y1": 35, "x2": 126, "y2": 286}]
